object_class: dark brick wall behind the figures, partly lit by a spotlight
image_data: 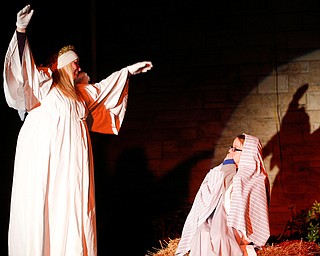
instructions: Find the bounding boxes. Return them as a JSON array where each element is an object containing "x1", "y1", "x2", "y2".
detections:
[{"x1": 1, "y1": 0, "x2": 320, "y2": 255}]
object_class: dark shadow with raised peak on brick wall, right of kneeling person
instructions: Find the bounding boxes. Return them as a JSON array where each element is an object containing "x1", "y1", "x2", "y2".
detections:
[{"x1": 263, "y1": 84, "x2": 320, "y2": 238}]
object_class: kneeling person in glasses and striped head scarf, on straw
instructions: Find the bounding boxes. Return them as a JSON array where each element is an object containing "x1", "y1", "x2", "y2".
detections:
[{"x1": 175, "y1": 133, "x2": 270, "y2": 256}]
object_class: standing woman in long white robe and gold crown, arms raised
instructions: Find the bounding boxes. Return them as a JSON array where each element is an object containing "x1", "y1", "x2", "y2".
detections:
[{"x1": 3, "y1": 5, "x2": 152, "y2": 256}]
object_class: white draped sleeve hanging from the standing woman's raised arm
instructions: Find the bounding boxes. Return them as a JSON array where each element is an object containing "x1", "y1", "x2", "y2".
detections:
[{"x1": 3, "y1": 32, "x2": 52, "y2": 120}]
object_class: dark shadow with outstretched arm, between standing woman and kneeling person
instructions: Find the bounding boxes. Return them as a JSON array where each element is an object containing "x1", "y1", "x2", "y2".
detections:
[{"x1": 96, "y1": 144, "x2": 212, "y2": 255}]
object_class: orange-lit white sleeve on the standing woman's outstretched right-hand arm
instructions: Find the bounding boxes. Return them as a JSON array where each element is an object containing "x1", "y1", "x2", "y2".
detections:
[{"x1": 78, "y1": 68, "x2": 129, "y2": 134}]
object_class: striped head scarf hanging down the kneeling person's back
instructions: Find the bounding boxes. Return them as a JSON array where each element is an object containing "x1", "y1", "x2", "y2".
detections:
[{"x1": 227, "y1": 134, "x2": 270, "y2": 246}]
